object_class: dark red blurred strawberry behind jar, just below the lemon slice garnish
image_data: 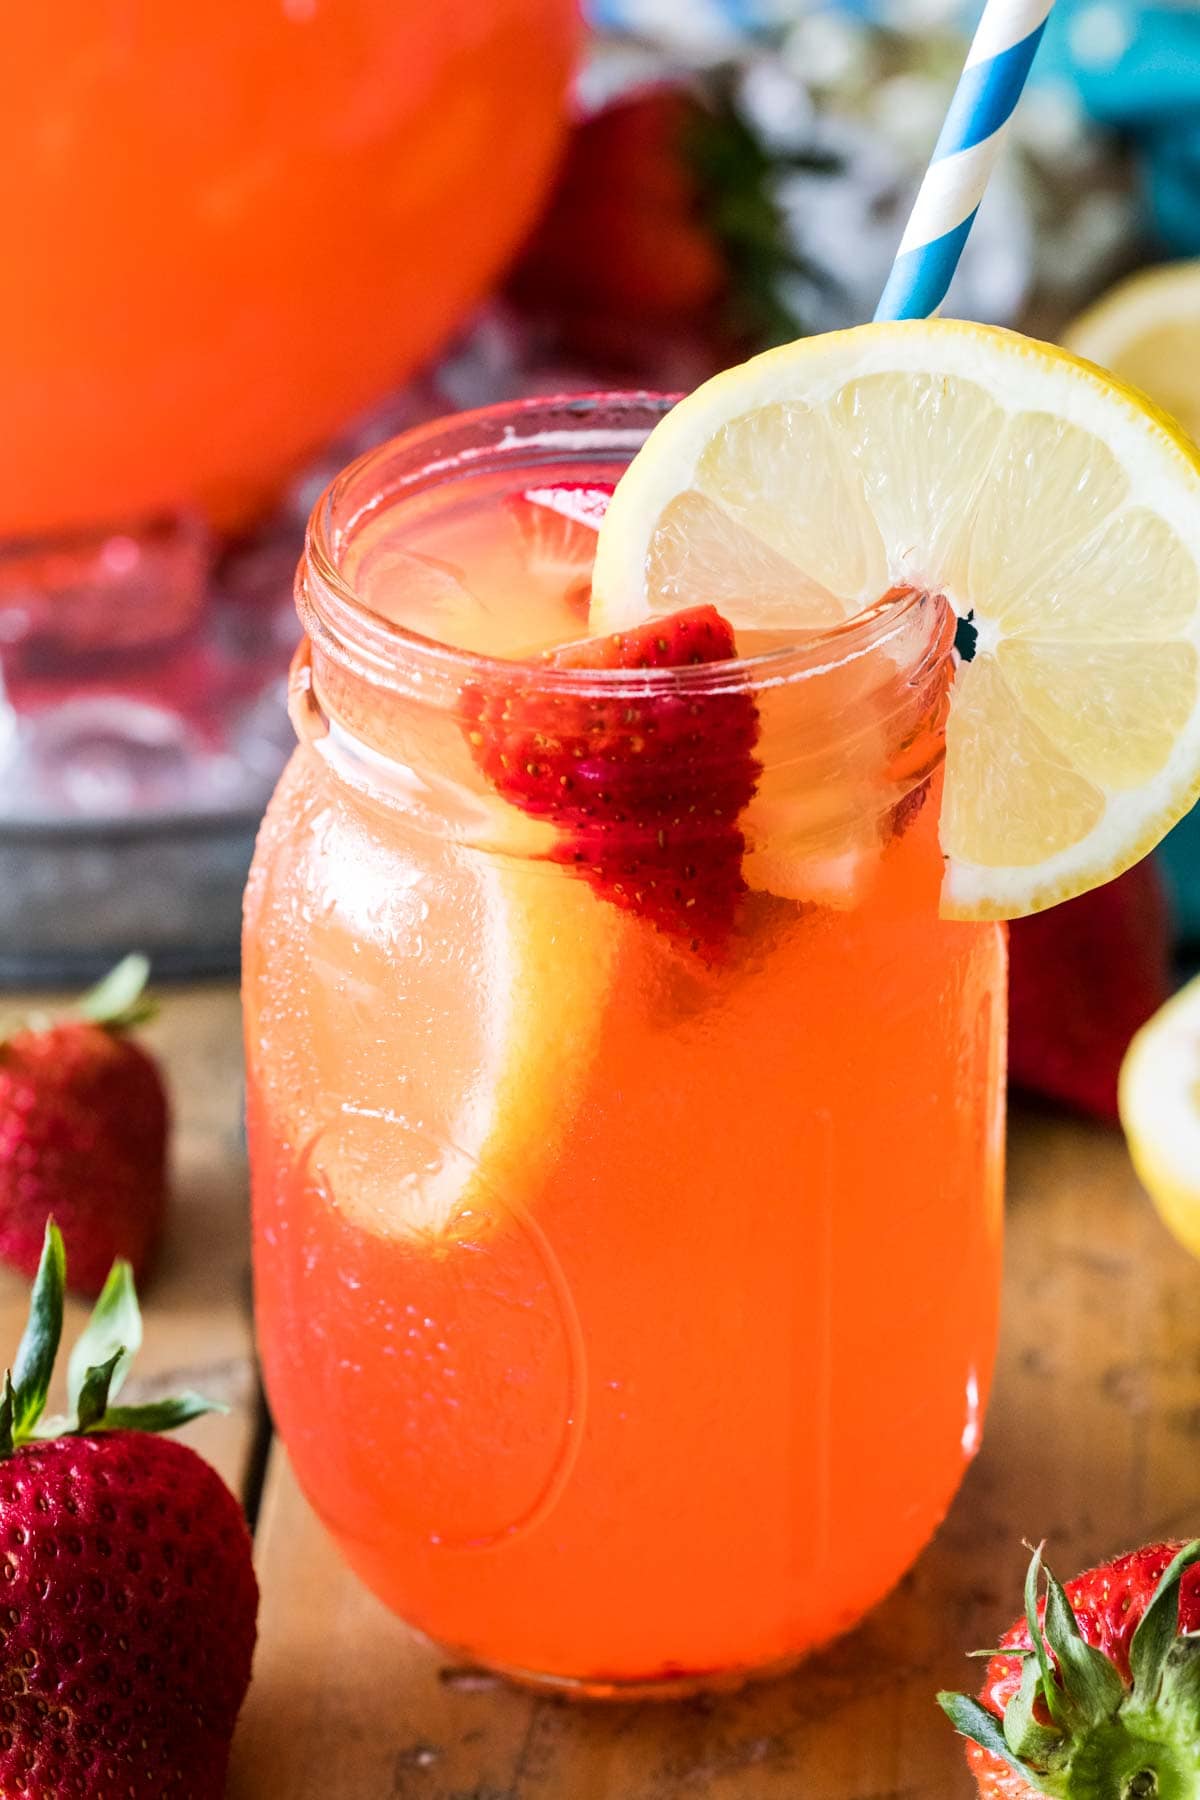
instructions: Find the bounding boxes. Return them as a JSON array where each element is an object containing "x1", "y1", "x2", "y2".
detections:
[{"x1": 1009, "y1": 859, "x2": 1173, "y2": 1120}]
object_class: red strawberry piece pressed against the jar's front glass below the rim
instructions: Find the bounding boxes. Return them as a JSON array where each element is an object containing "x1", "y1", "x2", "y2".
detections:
[{"x1": 464, "y1": 607, "x2": 759, "y2": 958}]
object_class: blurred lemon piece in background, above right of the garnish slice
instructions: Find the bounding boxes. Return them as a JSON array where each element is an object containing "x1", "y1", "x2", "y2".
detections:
[{"x1": 1065, "y1": 261, "x2": 1200, "y2": 453}]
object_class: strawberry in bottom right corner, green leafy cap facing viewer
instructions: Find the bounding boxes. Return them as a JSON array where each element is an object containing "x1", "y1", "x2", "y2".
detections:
[{"x1": 937, "y1": 1541, "x2": 1200, "y2": 1800}]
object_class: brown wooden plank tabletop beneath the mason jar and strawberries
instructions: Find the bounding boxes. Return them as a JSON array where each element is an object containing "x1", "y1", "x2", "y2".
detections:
[{"x1": 9, "y1": 986, "x2": 1200, "y2": 1800}]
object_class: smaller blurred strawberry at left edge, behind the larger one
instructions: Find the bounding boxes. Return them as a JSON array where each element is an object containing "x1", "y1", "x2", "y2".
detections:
[{"x1": 0, "y1": 956, "x2": 167, "y2": 1294}]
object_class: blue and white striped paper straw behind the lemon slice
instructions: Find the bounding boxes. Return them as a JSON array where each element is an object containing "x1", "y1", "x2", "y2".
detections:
[{"x1": 874, "y1": 0, "x2": 1054, "y2": 319}]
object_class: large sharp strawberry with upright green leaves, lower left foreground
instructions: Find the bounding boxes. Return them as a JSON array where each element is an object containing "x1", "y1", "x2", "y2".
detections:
[{"x1": 0, "y1": 1226, "x2": 257, "y2": 1800}]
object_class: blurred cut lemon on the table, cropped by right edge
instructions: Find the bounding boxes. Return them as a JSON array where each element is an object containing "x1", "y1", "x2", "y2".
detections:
[{"x1": 1119, "y1": 977, "x2": 1200, "y2": 1256}]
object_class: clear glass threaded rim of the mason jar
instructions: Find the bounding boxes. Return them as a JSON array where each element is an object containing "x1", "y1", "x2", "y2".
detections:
[{"x1": 297, "y1": 391, "x2": 945, "y2": 700}]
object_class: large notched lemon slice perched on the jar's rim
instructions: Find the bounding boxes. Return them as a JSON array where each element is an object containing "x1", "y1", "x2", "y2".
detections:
[{"x1": 592, "y1": 320, "x2": 1200, "y2": 918}]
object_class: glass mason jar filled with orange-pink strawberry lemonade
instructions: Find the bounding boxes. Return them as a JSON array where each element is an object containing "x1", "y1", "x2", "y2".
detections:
[{"x1": 245, "y1": 398, "x2": 1004, "y2": 1694}]
